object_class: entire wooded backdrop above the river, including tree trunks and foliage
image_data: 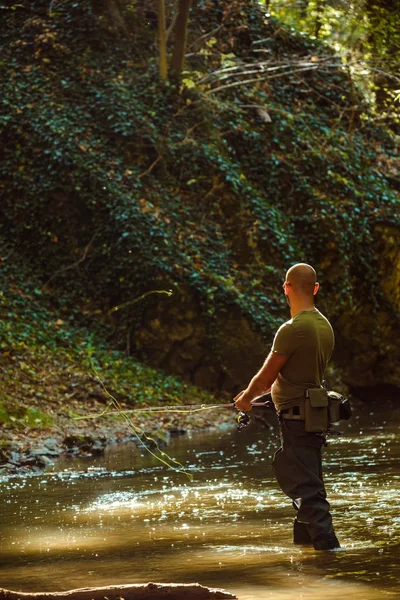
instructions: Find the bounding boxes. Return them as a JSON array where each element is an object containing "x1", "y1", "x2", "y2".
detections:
[{"x1": 0, "y1": 0, "x2": 400, "y2": 428}]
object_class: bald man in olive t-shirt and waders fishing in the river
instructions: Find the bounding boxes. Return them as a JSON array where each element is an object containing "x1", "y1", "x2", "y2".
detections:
[{"x1": 234, "y1": 263, "x2": 340, "y2": 550}]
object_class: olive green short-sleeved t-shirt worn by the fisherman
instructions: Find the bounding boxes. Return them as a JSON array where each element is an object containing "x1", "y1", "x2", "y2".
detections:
[{"x1": 271, "y1": 309, "x2": 335, "y2": 410}]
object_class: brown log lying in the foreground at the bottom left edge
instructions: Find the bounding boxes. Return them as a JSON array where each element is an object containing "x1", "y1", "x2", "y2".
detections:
[{"x1": 0, "y1": 583, "x2": 237, "y2": 600}]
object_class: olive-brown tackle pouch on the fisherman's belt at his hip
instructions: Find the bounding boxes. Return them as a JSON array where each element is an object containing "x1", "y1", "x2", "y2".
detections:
[{"x1": 304, "y1": 388, "x2": 351, "y2": 433}]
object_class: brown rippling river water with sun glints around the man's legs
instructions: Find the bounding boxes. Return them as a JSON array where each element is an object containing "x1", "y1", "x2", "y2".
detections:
[{"x1": 0, "y1": 407, "x2": 400, "y2": 600}]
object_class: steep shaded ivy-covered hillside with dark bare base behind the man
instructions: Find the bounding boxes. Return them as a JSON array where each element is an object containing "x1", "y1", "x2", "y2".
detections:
[{"x1": 0, "y1": 0, "x2": 400, "y2": 390}]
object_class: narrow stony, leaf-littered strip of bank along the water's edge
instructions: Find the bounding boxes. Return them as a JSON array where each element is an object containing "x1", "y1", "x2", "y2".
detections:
[{"x1": 0, "y1": 400, "x2": 236, "y2": 476}]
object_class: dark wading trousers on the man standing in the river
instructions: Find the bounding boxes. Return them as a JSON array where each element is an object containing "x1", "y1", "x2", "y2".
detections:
[{"x1": 272, "y1": 419, "x2": 334, "y2": 540}]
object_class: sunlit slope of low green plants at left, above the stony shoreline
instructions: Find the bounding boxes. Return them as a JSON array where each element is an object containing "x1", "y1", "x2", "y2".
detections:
[{"x1": 0, "y1": 238, "x2": 213, "y2": 428}]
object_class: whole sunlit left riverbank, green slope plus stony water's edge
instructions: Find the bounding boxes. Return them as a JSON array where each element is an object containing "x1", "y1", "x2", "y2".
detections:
[{"x1": 0, "y1": 251, "x2": 236, "y2": 475}]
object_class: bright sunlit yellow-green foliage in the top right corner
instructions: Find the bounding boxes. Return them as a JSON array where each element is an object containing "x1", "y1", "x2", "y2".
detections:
[{"x1": 264, "y1": 0, "x2": 400, "y2": 120}]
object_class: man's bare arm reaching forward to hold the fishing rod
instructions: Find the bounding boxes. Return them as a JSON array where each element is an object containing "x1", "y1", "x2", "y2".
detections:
[{"x1": 233, "y1": 352, "x2": 287, "y2": 410}]
